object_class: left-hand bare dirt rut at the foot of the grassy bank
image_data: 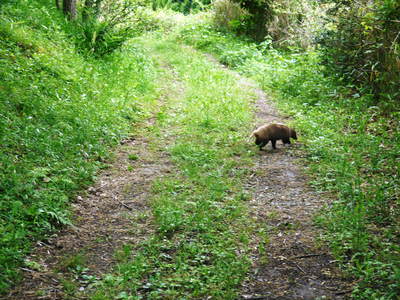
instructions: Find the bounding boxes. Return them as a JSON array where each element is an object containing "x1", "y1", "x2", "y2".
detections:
[{"x1": 5, "y1": 97, "x2": 171, "y2": 300}]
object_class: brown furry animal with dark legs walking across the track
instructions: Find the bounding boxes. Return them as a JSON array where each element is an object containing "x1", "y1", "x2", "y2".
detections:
[{"x1": 251, "y1": 124, "x2": 297, "y2": 150}]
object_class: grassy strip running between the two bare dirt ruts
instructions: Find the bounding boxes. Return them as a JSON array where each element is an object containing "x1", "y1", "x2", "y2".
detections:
[{"x1": 86, "y1": 36, "x2": 254, "y2": 300}]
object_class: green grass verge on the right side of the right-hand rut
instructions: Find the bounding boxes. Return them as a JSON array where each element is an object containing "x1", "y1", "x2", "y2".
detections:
[{"x1": 177, "y1": 23, "x2": 400, "y2": 299}]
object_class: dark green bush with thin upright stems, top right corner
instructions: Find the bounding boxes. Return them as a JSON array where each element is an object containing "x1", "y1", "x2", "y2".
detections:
[{"x1": 319, "y1": 0, "x2": 400, "y2": 101}]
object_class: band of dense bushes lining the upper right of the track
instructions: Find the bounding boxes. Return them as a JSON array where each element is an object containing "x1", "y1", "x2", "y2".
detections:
[{"x1": 213, "y1": 0, "x2": 400, "y2": 102}]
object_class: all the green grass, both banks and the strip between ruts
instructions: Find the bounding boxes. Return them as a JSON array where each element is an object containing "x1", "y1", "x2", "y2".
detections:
[{"x1": 0, "y1": 0, "x2": 400, "y2": 299}]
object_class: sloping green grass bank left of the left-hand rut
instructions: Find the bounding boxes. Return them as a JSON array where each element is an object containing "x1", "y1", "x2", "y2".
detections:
[{"x1": 0, "y1": 1, "x2": 155, "y2": 292}]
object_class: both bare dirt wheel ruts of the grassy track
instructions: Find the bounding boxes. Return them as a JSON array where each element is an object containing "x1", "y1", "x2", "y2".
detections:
[{"x1": 5, "y1": 41, "x2": 349, "y2": 300}]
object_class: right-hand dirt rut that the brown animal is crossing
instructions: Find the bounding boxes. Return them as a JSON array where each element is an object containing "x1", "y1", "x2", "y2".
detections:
[{"x1": 239, "y1": 78, "x2": 350, "y2": 300}]
